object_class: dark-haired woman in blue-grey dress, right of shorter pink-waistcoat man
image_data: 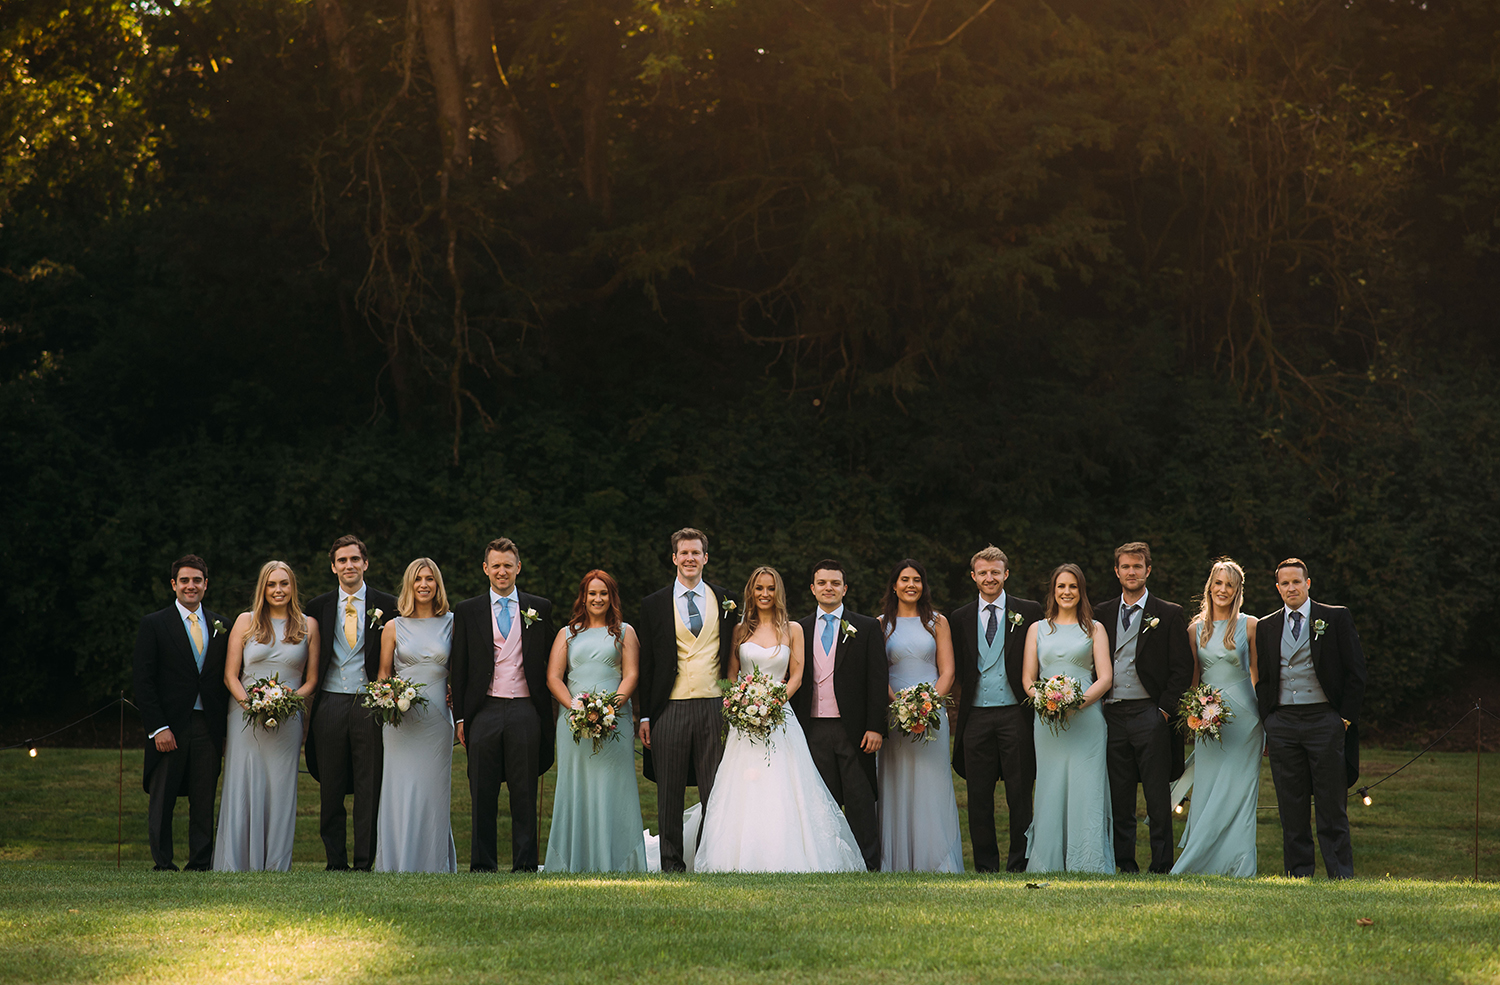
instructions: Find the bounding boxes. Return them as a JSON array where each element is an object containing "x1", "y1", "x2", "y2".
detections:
[{"x1": 878, "y1": 558, "x2": 963, "y2": 873}]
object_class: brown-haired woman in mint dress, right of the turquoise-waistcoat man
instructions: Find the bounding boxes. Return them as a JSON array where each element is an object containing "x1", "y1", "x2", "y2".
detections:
[{"x1": 1022, "y1": 564, "x2": 1115, "y2": 873}]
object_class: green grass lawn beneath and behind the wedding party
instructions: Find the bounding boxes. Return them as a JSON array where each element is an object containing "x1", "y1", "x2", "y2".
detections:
[{"x1": 0, "y1": 750, "x2": 1500, "y2": 985}]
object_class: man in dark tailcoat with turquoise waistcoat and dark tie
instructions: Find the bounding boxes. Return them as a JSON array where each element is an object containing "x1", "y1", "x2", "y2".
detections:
[{"x1": 948, "y1": 546, "x2": 1041, "y2": 873}]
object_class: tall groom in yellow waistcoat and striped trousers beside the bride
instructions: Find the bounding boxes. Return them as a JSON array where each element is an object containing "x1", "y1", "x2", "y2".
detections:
[{"x1": 636, "y1": 526, "x2": 740, "y2": 873}]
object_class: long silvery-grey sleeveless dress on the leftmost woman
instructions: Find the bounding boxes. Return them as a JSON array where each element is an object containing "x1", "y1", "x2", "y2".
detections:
[{"x1": 213, "y1": 619, "x2": 308, "y2": 873}]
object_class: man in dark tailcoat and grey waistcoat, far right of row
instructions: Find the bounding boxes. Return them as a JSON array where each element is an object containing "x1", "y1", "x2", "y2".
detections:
[{"x1": 1256, "y1": 558, "x2": 1365, "y2": 879}]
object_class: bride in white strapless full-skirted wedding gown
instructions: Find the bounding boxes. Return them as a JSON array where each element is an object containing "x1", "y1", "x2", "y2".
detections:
[{"x1": 693, "y1": 567, "x2": 866, "y2": 873}]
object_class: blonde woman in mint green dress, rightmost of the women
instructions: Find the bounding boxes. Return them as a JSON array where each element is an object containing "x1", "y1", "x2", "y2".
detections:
[{"x1": 1172, "y1": 558, "x2": 1266, "y2": 879}]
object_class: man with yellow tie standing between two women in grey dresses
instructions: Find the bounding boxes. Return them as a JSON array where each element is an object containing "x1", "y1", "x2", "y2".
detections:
[{"x1": 305, "y1": 534, "x2": 396, "y2": 873}]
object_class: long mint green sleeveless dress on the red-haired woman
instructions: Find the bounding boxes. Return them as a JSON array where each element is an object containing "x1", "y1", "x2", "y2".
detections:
[{"x1": 543, "y1": 627, "x2": 647, "y2": 873}]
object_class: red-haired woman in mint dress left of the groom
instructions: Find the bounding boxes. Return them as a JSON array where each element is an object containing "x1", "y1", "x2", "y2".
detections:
[{"x1": 543, "y1": 570, "x2": 647, "y2": 873}]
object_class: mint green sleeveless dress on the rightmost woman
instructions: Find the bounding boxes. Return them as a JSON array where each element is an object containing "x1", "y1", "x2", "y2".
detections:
[{"x1": 1172, "y1": 616, "x2": 1266, "y2": 879}]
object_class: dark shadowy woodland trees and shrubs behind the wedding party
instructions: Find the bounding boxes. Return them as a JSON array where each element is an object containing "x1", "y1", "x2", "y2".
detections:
[{"x1": 0, "y1": 0, "x2": 1500, "y2": 720}]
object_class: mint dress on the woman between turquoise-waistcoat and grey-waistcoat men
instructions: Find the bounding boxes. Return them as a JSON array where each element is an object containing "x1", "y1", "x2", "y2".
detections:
[{"x1": 1026, "y1": 621, "x2": 1115, "y2": 873}]
